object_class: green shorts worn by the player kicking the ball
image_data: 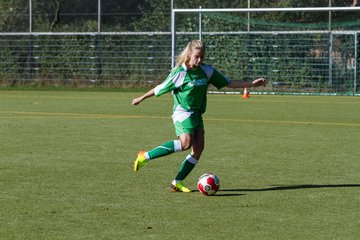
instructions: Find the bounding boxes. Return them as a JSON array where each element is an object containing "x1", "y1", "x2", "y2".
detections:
[{"x1": 174, "y1": 112, "x2": 204, "y2": 136}]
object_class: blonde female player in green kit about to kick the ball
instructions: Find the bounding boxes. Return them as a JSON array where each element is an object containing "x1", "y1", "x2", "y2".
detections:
[{"x1": 132, "y1": 40, "x2": 266, "y2": 192}]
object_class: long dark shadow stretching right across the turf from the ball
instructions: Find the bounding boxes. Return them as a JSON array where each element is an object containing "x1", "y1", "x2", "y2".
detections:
[{"x1": 216, "y1": 184, "x2": 360, "y2": 196}]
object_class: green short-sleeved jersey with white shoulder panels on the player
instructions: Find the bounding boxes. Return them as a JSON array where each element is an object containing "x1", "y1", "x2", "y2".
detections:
[{"x1": 155, "y1": 64, "x2": 230, "y2": 114}]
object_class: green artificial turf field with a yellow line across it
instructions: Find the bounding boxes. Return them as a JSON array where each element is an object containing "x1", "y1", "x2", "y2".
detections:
[{"x1": 0, "y1": 91, "x2": 360, "y2": 240}]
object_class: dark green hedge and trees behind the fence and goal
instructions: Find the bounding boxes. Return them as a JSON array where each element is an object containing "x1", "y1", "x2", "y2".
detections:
[{"x1": 0, "y1": 0, "x2": 360, "y2": 92}]
